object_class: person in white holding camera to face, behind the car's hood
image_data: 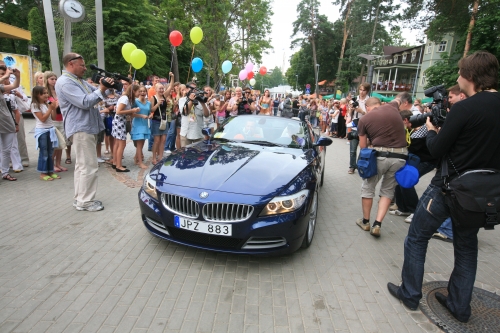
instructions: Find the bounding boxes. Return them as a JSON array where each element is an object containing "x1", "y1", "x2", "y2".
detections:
[{"x1": 179, "y1": 82, "x2": 210, "y2": 147}]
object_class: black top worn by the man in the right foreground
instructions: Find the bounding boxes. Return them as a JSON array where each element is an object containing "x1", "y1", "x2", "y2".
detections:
[{"x1": 427, "y1": 91, "x2": 500, "y2": 186}]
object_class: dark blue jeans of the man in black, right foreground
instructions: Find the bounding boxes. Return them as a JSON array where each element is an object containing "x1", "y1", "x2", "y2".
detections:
[{"x1": 398, "y1": 184, "x2": 479, "y2": 321}]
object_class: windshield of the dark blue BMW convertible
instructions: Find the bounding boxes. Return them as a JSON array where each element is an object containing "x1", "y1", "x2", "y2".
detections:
[{"x1": 213, "y1": 115, "x2": 311, "y2": 148}]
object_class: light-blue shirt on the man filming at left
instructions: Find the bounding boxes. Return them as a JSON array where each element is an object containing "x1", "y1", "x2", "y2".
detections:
[{"x1": 56, "y1": 71, "x2": 104, "y2": 138}]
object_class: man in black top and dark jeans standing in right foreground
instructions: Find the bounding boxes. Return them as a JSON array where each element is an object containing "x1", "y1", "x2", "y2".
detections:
[{"x1": 387, "y1": 51, "x2": 500, "y2": 322}]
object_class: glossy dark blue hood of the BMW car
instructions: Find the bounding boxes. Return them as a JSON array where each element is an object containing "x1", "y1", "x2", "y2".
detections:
[{"x1": 157, "y1": 142, "x2": 313, "y2": 195}]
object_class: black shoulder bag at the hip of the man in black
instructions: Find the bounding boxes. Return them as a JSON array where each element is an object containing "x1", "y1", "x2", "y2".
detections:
[{"x1": 441, "y1": 158, "x2": 500, "y2": 230}]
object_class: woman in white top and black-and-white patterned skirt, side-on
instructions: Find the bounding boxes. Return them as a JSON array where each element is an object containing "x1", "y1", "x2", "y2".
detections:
[{"x1": 111, "y1": 84, "x2": 140, "y2": 172}]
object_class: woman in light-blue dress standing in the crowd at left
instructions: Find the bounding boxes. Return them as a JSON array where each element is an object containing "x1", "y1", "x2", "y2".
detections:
[{"x1": 130, "y1": 86, "x2": 153, "y2": 169}]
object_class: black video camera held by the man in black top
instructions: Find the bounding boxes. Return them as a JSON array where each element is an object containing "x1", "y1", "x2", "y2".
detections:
[{"x1": 410, "y1": 85, "x2": 450, "y2": 128}]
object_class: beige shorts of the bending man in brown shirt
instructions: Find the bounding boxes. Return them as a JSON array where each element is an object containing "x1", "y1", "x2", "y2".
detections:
[{"x1": 361, "y1": 153, "x2": 406, "y2": 199}]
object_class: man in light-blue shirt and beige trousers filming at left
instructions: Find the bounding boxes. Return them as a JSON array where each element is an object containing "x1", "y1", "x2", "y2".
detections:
[{"x1": 56, "y1": 53, "x2": 114, "y2": 212}]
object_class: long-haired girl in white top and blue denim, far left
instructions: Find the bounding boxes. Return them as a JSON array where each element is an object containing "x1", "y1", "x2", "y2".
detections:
[{"x1": 31, "y1": 86, "x2": 61, "y2": 181}]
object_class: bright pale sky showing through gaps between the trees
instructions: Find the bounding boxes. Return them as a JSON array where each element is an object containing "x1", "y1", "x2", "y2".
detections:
[{"x1": 261, "y1": 0, "x2": 417, "y2": 71}]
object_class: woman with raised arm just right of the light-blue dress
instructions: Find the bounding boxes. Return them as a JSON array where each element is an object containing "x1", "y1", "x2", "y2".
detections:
[{"x1": 149, "y1": 73, "x2": 174, "y2": 164}]
